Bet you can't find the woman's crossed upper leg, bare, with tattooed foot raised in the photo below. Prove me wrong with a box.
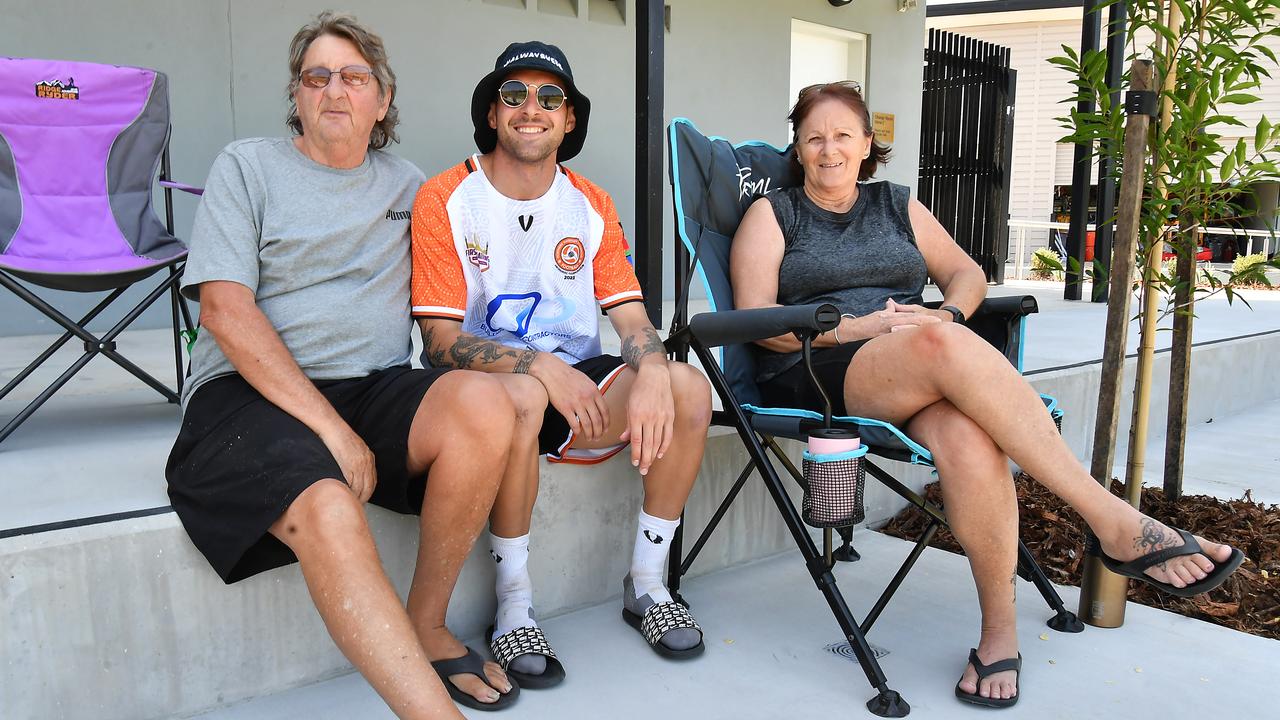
[845,323,1231,587]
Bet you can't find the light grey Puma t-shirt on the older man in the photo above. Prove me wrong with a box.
[182,138,425,406]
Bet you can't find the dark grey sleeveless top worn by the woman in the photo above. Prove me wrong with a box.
[756,182,928,382]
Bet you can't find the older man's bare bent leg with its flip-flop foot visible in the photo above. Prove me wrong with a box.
[408,372,515,702]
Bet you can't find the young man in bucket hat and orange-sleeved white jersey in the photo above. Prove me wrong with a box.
[412,42,710,702]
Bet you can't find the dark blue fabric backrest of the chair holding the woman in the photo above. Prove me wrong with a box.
[668,118,803,405]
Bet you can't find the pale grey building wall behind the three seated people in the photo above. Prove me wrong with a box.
[0,0,924,336]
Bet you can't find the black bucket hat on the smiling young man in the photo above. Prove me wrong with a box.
[471,41,591,163]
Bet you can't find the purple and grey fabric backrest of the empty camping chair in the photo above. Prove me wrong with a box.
[0,58,186,290]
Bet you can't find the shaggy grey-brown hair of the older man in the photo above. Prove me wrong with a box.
[285,10,399,150]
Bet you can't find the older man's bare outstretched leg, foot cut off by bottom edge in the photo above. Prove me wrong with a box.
[270,479,462,720]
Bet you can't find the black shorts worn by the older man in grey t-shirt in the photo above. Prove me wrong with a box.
[165,368,445,584]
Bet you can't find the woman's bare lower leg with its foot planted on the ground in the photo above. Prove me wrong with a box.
[906,400,1018,698]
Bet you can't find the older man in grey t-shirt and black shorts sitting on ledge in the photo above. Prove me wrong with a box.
[166,13,517,719]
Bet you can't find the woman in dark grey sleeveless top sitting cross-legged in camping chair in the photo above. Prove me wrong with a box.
[731,82,1239,707]
